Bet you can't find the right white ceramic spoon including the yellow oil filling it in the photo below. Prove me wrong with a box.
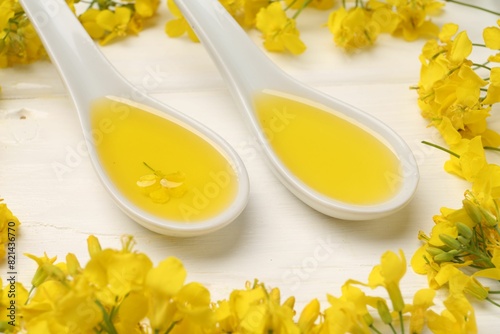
[175,0,419,220]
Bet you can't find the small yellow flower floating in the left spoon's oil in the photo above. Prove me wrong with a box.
[137,163,187,203]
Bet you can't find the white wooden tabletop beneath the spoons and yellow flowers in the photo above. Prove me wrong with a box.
[0,0,500,333]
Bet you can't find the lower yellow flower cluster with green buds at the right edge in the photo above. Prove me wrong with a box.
[412,136,500,306]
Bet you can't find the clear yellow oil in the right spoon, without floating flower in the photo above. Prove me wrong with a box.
[254,91,402,205]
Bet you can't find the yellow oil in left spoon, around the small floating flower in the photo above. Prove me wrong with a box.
[91,97,238,222]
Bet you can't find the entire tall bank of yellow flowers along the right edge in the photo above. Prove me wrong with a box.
[412,11,500,322]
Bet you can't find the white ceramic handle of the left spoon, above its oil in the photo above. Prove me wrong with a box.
[19,0,128,114]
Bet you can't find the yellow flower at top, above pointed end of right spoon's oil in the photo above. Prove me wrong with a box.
[255,2,306,55]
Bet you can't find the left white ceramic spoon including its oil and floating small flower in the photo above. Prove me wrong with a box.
[20,0,249,236]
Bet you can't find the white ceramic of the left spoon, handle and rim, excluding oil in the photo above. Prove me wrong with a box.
[20,0,249,236]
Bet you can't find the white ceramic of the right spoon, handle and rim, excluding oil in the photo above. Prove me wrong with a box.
[175,0,419,220]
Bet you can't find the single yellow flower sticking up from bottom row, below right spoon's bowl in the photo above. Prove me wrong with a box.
[368,250,406,312]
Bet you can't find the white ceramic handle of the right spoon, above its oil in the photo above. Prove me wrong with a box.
[174,0,286,100]
